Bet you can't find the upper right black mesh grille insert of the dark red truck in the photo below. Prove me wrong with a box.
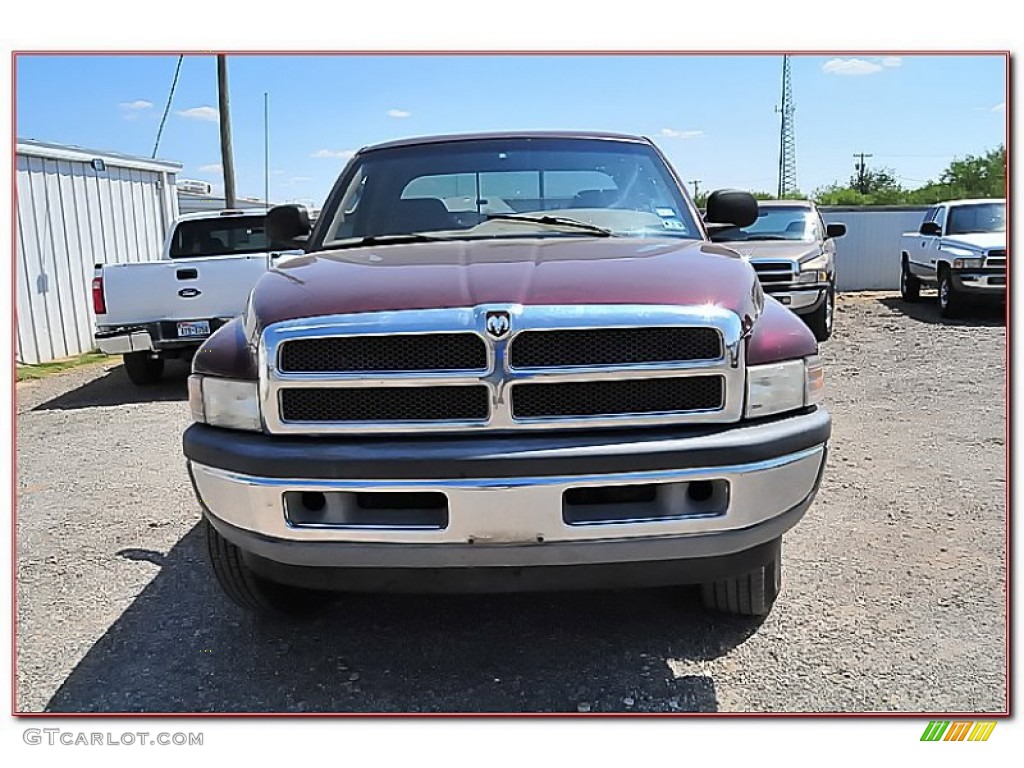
[509,328,722,369]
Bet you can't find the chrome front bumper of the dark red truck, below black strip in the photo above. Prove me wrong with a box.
[189,444,826,567]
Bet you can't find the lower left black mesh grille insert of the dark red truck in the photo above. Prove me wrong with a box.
[281,386,489,422]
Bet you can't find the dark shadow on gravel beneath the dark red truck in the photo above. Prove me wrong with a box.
[46,525,761,713]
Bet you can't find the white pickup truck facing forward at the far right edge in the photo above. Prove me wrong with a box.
[900,199,1007,317]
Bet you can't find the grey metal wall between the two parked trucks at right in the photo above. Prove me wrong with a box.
[821,206,928,291]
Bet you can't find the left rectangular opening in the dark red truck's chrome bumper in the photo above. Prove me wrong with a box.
[284,490,449,530]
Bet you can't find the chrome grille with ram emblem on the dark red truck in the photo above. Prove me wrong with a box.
[259,304,744,434]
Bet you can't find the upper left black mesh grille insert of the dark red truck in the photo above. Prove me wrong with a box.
[280,333,487,373]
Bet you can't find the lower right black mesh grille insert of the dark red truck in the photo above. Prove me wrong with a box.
[512,376,725,419]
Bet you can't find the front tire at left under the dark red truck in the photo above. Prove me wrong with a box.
[203,518,331,618]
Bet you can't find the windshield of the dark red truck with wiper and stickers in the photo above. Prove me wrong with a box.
[322,137,703,248]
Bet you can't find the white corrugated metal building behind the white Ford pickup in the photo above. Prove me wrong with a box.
[15,139,181,364]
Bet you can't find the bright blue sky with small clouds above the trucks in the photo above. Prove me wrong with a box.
[16,54,1006,205]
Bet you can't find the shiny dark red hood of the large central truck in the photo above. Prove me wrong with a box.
[252,238,760,328]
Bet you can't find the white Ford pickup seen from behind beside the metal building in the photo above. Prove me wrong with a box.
[92,209,281,385]
